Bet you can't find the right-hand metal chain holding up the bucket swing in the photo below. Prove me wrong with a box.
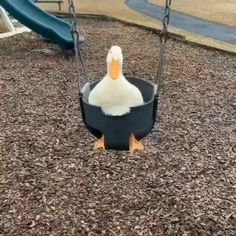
[156,0,171,96]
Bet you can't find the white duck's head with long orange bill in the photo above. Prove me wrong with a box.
[107,46,123,80]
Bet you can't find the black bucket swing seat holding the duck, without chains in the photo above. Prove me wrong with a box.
[80,77,158,150]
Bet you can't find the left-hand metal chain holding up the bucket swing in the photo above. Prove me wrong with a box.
[68,0,88,94]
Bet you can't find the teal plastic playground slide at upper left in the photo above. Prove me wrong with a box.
[0,0,84,49]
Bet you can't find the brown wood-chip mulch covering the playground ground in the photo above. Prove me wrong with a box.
[0,19,236,236]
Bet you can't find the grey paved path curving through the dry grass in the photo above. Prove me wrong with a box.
[126,0,236,45]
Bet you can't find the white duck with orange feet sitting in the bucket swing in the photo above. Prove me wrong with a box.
[88,45,144,152]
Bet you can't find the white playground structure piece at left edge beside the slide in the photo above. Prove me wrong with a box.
[0,6,31,38]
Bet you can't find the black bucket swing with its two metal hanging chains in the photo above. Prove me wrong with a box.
[69,0,171,150]
